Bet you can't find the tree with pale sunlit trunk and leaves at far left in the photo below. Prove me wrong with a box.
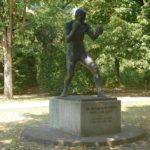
[0,0,46,99]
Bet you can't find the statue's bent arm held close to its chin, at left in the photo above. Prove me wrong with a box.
[64,21,80,42]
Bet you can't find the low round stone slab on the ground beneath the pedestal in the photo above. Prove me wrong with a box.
[21,124,145,146]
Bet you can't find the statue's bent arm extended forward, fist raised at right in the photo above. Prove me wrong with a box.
[87,25,103,41]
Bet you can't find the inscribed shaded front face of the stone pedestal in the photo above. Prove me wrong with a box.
[81,101,121,136]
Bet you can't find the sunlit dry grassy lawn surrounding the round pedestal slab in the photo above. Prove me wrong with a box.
[0,97,150,150]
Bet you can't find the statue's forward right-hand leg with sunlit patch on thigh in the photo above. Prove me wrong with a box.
[82,55,106,97]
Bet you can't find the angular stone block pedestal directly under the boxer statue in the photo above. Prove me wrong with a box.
[49,96,121,136]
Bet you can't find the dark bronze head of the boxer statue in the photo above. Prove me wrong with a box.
[75,8,86,22]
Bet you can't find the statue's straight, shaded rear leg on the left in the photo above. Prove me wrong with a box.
[60,60,75,97]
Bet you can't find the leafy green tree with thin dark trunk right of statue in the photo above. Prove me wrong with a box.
[75,0,143,87]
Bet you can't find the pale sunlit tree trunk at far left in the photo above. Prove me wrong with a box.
[3,0,14,99]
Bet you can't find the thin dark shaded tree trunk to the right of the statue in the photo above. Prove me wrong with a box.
[115,57,120,87]
